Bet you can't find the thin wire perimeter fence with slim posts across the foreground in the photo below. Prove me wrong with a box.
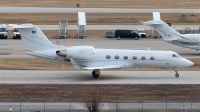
[0,91,200,112]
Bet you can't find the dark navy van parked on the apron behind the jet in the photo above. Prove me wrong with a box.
[115,29,140,40]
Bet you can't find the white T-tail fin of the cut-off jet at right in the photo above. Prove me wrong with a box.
[143,12,182,41]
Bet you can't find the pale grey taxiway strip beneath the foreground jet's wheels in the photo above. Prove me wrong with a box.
[0,70,200,84]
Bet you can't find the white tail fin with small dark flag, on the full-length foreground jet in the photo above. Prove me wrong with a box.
[8,24,55,51]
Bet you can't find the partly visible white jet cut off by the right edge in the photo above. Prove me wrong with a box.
[143,12,200,50]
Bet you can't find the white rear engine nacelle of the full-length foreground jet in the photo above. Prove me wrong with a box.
[56,46,95,59]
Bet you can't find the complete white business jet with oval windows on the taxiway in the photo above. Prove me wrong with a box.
[9,24,194,78]
